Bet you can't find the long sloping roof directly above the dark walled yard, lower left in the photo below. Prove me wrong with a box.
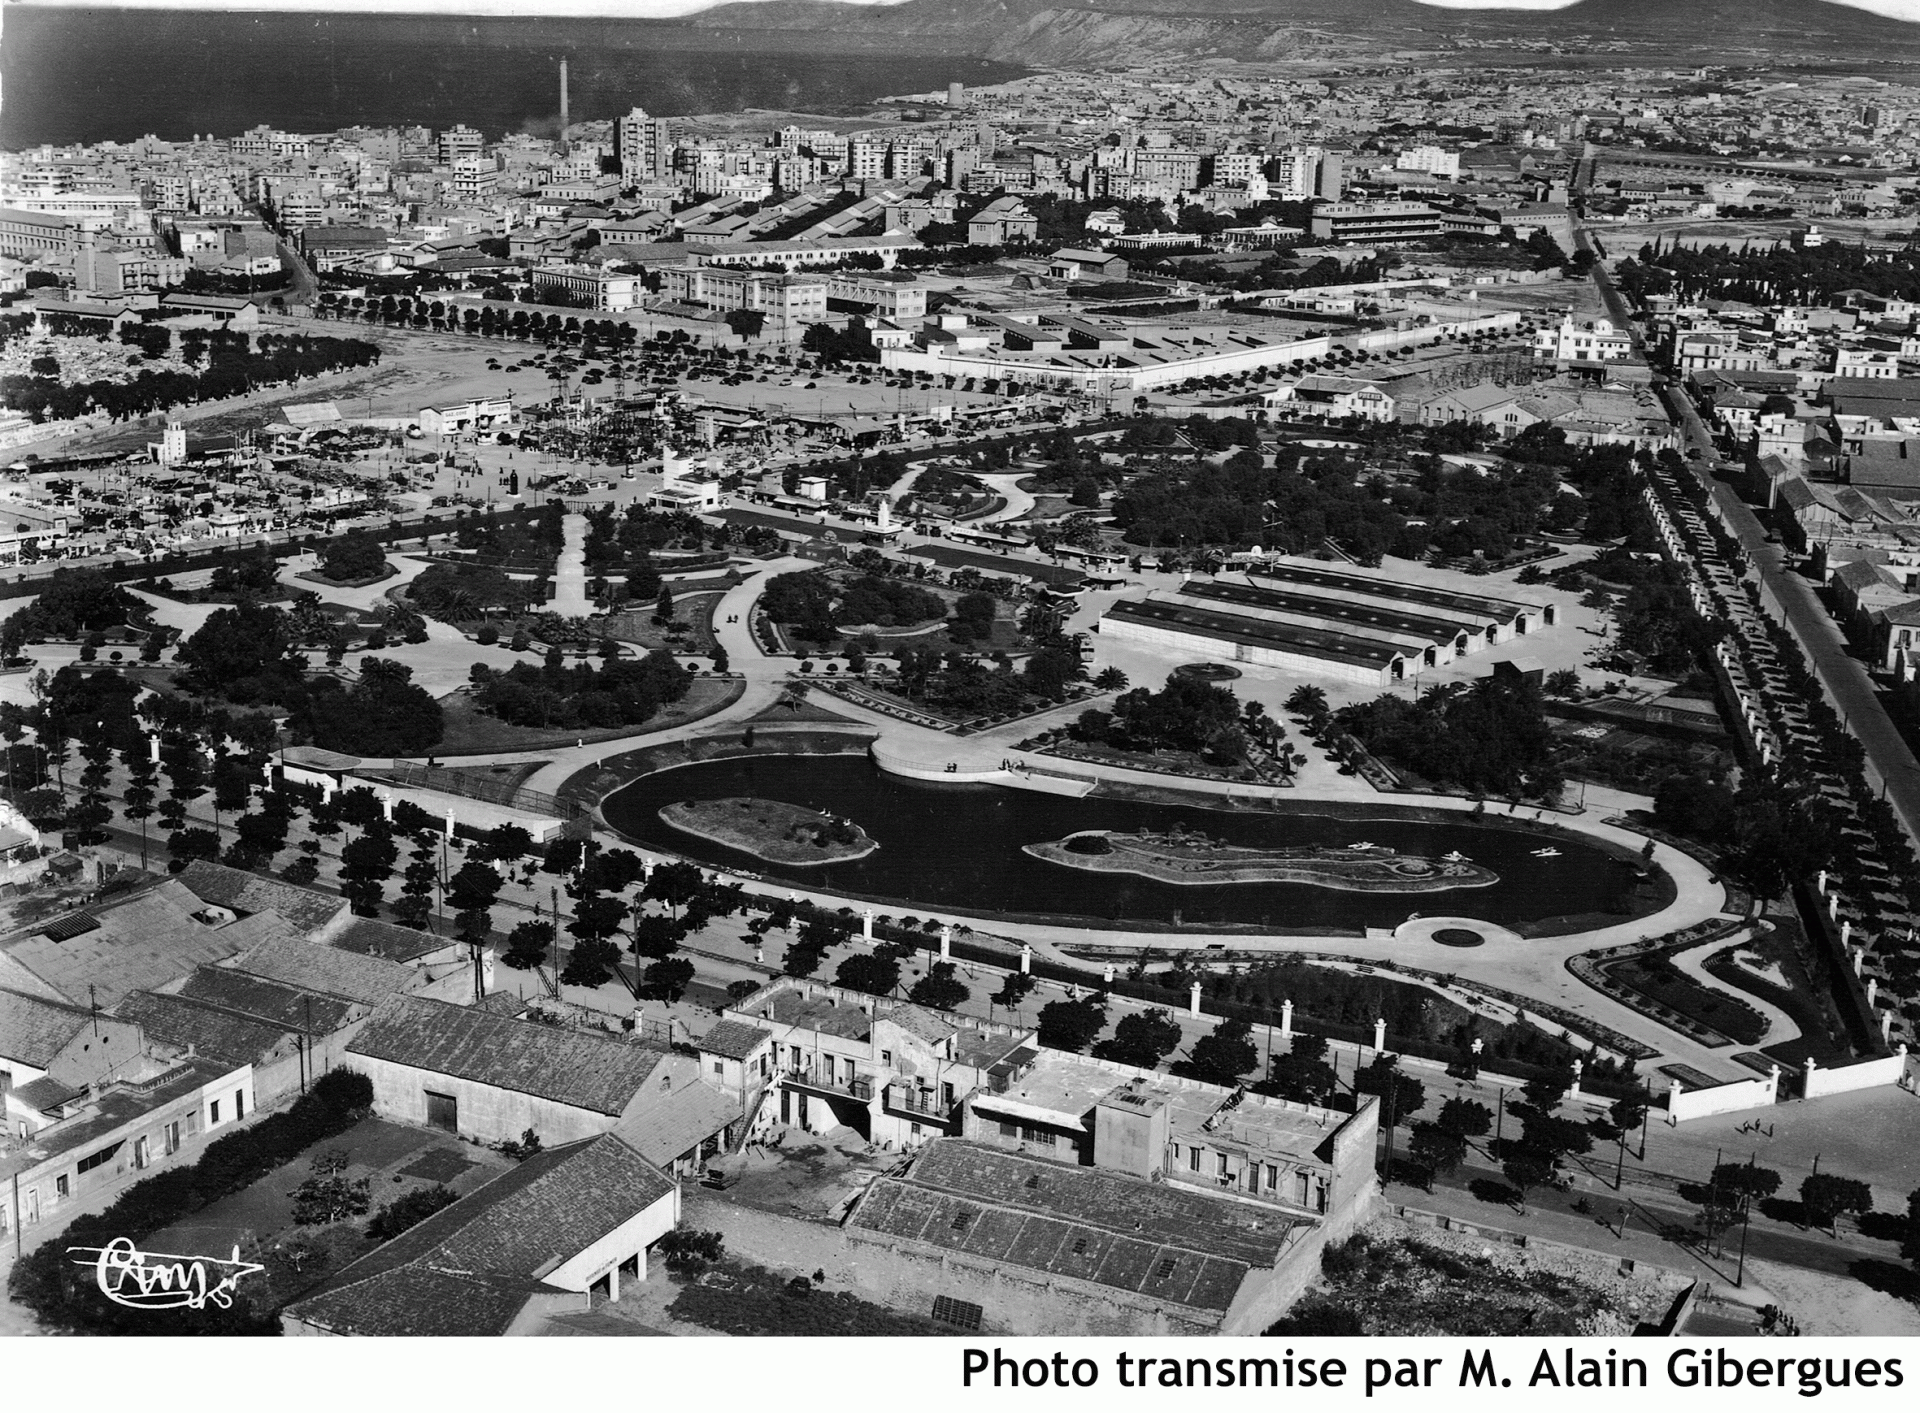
[348,996,666,1115]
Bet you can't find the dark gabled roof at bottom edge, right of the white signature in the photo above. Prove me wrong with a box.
[288,1135,674,1334]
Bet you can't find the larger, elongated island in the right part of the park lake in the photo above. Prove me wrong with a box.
[1023,829,1500,893]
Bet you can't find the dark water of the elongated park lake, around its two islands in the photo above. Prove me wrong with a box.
[601,754,1670,933]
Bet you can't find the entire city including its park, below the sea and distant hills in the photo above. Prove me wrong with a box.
[0,56,1920,1338]
